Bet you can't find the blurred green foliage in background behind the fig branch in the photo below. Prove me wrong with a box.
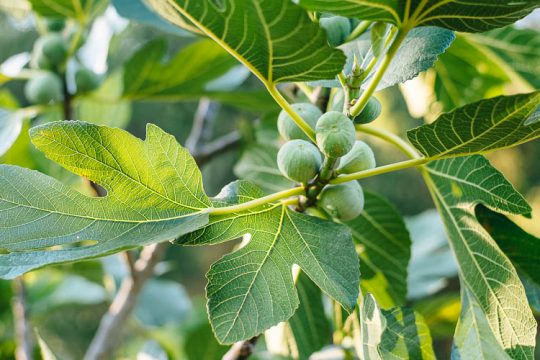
[0,0,540,360]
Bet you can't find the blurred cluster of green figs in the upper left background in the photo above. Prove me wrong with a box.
[24,19,101,104]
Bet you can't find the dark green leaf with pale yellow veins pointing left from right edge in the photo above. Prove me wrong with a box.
[407,91,540,159]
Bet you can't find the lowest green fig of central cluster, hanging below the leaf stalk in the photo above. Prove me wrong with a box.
[317,181,364,221]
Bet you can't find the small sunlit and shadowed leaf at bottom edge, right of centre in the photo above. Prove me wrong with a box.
[355,294,435,360]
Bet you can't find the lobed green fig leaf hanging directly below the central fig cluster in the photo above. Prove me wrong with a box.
[178,182,360,343]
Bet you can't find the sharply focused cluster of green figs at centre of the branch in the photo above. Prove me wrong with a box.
[277,98,381,221]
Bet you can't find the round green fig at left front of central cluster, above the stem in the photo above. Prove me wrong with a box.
[277,139,322,184]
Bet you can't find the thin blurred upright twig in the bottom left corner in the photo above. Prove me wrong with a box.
[12,277,33,360]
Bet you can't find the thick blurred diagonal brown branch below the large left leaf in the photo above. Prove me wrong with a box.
[84,243,169,360]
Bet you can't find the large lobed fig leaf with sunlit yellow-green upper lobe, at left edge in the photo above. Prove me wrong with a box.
[0,122,212,278]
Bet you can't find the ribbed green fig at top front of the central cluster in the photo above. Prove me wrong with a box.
[315,111,356,158]
